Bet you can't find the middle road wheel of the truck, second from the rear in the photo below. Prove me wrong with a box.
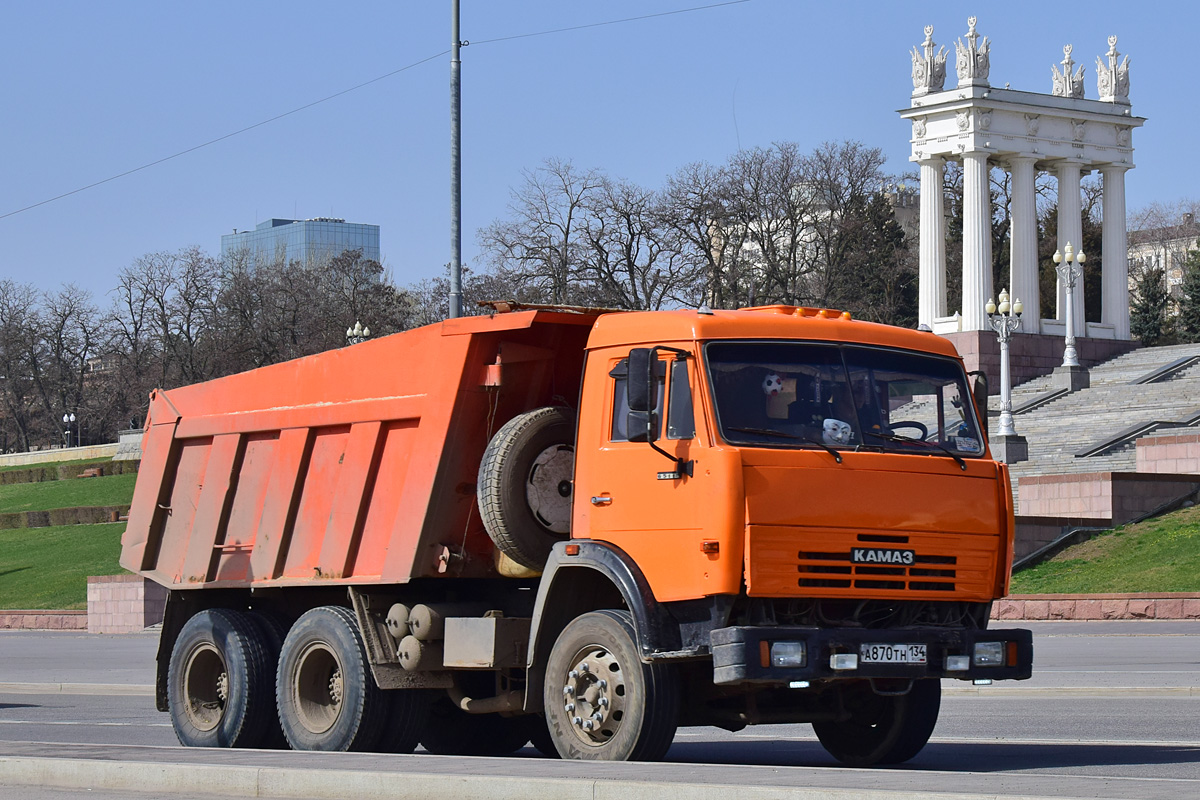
[275,606,386,751]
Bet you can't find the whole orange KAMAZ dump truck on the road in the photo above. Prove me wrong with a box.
[121,305,1033,765]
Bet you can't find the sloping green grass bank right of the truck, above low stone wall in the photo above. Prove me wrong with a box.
[1010,506,1200,595]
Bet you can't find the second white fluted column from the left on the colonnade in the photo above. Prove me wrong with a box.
[962,152,992,331]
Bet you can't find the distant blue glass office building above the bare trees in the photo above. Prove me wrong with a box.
[221,217,379,264]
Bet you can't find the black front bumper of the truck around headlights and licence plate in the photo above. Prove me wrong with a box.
[712,626,1033,685]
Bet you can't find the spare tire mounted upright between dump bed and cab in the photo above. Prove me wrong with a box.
[476,408,575,570]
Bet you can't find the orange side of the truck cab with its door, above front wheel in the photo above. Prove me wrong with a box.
[572,347,744,601]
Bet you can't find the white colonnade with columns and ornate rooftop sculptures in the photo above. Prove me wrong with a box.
[900,17,1145,339]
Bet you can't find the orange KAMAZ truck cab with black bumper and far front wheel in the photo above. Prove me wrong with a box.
[535,306,1032,764]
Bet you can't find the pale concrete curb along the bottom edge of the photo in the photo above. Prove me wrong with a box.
[0,758,1099,800]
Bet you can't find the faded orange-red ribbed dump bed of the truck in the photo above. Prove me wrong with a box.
[121,311,596,589]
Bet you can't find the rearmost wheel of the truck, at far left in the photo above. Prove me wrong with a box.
[167,608,274,747]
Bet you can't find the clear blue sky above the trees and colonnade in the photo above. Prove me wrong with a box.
[0,0,1185,303]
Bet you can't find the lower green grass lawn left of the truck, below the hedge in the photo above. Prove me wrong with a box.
[0,522,125,608]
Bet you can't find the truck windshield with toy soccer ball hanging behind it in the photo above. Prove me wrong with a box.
[704,342,983,457]
